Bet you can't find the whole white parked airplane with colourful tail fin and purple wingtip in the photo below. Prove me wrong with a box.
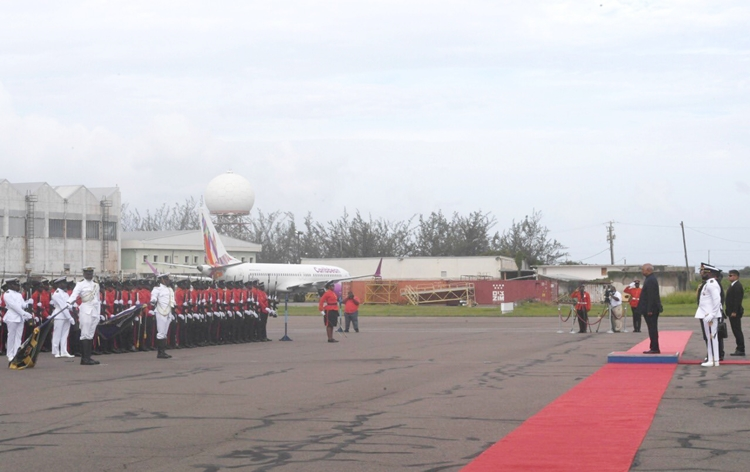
[162,208,383,293]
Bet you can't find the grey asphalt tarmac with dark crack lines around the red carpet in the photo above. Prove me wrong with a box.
[0,317,750,472]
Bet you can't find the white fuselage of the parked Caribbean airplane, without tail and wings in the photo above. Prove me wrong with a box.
[200,262,349,292]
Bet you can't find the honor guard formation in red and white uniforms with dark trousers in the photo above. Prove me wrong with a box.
[0,267,278,365]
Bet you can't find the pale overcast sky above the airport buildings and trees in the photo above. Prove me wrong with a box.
[0,0,750,269]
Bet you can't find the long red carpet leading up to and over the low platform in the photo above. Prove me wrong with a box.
[462,331,692,472]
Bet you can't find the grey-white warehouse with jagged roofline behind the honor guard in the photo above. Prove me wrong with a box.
[0,179,121,278]
